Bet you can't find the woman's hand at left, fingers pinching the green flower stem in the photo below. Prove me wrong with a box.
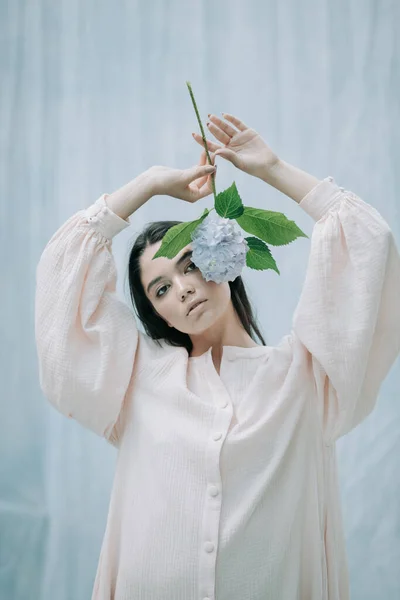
[148,150,216,202]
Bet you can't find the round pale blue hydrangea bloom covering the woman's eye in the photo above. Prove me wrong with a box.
[191,212,249,283]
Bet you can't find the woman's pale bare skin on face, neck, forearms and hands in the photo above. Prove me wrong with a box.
[106,113,319,372]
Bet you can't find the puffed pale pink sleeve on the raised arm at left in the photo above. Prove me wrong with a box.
[35,194,140,446]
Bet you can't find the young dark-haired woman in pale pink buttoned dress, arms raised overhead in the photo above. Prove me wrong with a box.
[35,115,400,600]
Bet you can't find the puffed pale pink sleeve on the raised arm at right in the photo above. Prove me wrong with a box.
[291,177,400,444]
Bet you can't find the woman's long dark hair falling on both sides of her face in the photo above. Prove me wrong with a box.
[127,221,266,354]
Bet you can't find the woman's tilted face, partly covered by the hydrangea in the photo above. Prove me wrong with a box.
[140,241,231,334]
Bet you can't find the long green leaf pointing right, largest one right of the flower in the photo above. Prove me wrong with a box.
[236,206,308,246]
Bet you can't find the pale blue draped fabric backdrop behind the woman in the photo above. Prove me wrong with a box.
[0,0,400,600]
